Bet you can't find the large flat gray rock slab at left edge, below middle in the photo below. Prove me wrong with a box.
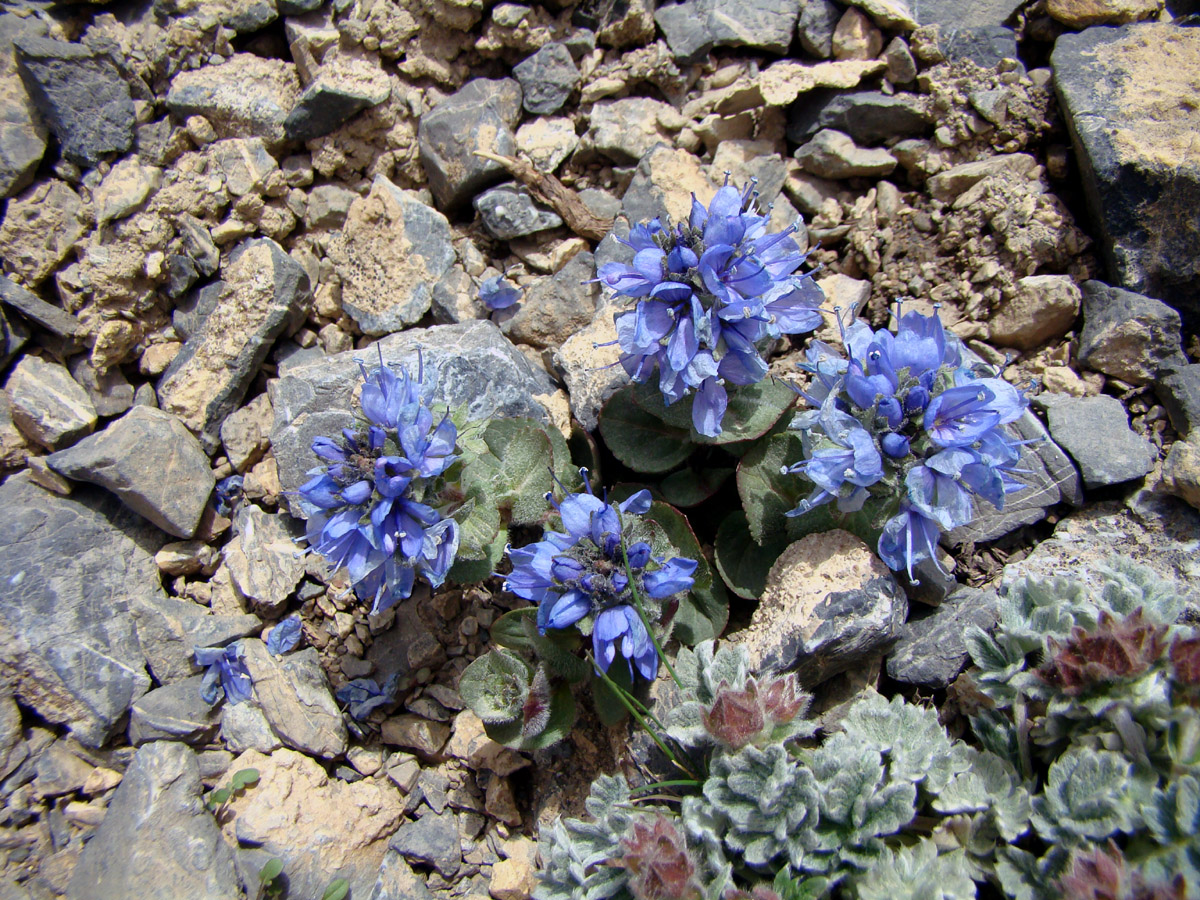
[0,474,162,746]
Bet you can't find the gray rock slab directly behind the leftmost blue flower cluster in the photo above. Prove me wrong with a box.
[271,319,554,515]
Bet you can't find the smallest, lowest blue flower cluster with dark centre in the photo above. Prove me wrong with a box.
[504,469,697,680]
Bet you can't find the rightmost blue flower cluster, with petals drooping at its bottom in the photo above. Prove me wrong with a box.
[784,312,1028,577]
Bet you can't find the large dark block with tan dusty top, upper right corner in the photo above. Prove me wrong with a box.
[1050,23,1200,328]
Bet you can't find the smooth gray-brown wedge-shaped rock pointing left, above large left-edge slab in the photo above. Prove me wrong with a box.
[47,407,215,538]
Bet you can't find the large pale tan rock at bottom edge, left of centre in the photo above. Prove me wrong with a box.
[224,750,403,898]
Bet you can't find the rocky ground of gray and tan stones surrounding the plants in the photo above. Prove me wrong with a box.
[0,0,1200,900]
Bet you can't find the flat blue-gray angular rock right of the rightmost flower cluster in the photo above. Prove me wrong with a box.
[1038,394,1157,487]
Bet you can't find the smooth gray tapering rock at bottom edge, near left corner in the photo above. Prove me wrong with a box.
[67,742,241,900]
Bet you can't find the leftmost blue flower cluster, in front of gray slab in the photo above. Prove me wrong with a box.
[299,360,460,614]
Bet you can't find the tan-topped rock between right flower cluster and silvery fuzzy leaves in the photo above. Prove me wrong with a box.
[733,530,908,686]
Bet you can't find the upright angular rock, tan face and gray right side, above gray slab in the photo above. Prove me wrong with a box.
[326,175,455,335]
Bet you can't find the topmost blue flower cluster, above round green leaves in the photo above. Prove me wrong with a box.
[598,184,824,437]
